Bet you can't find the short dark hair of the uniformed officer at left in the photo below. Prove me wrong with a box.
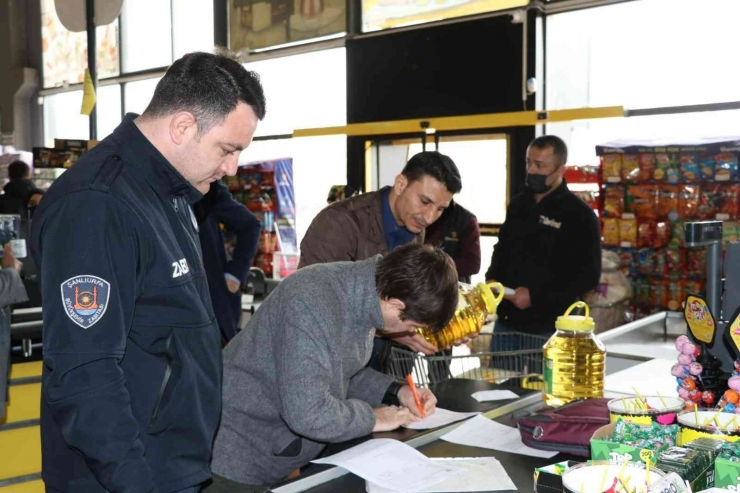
[142,49,266,135]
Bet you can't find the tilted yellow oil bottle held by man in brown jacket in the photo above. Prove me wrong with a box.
[418,282,504,349]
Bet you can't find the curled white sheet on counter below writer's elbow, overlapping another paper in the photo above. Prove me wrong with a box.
[311,438,461,491]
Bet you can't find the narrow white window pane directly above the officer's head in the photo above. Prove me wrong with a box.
[172,0,213,60]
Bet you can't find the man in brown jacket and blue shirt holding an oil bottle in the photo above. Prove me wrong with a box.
[298,152,462,370]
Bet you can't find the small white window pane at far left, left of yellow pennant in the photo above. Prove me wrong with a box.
[44,91,90,147]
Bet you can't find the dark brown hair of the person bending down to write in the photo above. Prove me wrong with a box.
[375,243,459,331]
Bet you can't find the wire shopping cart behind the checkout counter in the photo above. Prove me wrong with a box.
[389,332,548,390]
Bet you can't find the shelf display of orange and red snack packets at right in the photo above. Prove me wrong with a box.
[596,136,740,318]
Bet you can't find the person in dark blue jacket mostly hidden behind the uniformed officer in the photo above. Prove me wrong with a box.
[194,180,262,343]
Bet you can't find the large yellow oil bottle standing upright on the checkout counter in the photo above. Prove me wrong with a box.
[542,301,606,407]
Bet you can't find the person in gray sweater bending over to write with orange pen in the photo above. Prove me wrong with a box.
[208,244,458,493]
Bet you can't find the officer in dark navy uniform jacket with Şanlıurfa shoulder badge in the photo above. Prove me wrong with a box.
[31,53,265,493]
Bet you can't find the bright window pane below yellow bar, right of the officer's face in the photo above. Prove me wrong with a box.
[239,135,347,245]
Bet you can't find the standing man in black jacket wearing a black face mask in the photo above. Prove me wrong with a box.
[486,135,601,350]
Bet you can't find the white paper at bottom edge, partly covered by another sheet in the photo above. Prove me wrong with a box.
[365,457,516,493]
